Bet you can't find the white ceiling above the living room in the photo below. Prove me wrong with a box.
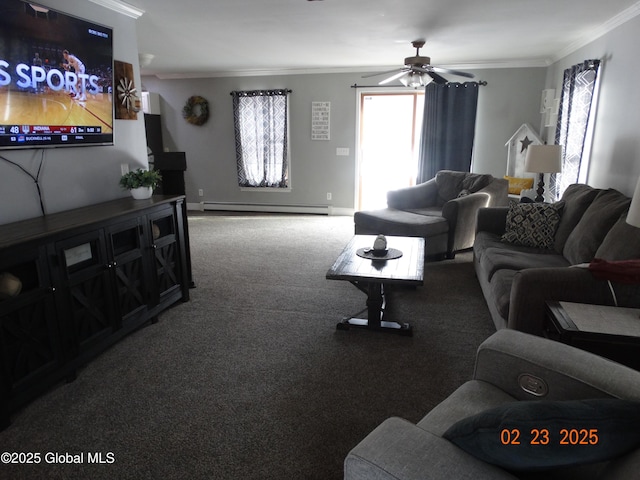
[99,0,640,78]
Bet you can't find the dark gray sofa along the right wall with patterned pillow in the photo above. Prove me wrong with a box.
[473,184,640,335]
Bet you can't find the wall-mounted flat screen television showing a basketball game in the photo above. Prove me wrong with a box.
[0,0,114,149]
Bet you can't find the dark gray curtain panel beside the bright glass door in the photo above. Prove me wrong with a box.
[417,82,479,183]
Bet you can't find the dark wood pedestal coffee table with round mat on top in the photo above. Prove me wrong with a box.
[327,235,424,336]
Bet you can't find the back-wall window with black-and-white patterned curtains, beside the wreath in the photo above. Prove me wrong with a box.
[231,90,291,188]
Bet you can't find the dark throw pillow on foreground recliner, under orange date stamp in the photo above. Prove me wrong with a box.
[443,398,640,471]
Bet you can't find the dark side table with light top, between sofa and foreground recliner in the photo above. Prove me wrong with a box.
[544,301,640,370]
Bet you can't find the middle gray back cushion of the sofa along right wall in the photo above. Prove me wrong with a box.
[562,189,631,265]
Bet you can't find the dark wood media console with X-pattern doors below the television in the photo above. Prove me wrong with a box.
[0,196,191,429]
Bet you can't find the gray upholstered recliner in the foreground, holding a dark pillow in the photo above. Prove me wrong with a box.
[344,329,640,480]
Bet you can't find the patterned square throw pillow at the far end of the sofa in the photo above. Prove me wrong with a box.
[502,201,564,248]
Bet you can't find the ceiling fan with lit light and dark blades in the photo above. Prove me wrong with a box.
[362,40,473,88]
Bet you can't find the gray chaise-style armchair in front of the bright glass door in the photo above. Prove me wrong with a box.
[354,170,509,258]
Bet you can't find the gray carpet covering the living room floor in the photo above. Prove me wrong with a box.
[0,214,494,480]
